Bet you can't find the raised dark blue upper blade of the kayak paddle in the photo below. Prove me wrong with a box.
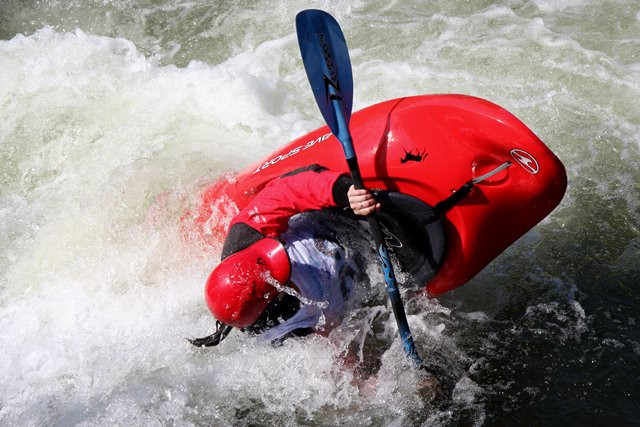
[296,9,353,135]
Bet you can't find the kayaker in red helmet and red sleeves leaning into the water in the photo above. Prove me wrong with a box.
[190,165,380,346]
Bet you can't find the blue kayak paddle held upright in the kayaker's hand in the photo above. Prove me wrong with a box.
[296,9,422,365]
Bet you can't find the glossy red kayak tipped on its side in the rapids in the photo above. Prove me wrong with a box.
[192,95,567,295]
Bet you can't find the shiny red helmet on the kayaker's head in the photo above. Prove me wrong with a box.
[205,238,291,328]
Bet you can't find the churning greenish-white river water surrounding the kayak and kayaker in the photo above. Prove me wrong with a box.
[0,0,640,425]
